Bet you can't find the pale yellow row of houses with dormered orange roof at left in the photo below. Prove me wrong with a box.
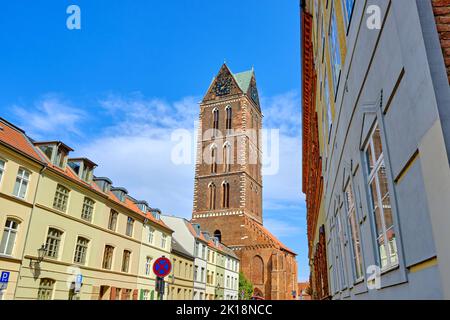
[0,119,173,300]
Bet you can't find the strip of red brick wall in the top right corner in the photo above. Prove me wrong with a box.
[432,0,450,83]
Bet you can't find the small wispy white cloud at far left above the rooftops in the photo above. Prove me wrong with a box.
[12,95,87,140]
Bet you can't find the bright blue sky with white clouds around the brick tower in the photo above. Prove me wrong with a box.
[0,0,309,280]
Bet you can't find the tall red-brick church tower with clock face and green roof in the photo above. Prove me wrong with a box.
[192,64,297,299]
